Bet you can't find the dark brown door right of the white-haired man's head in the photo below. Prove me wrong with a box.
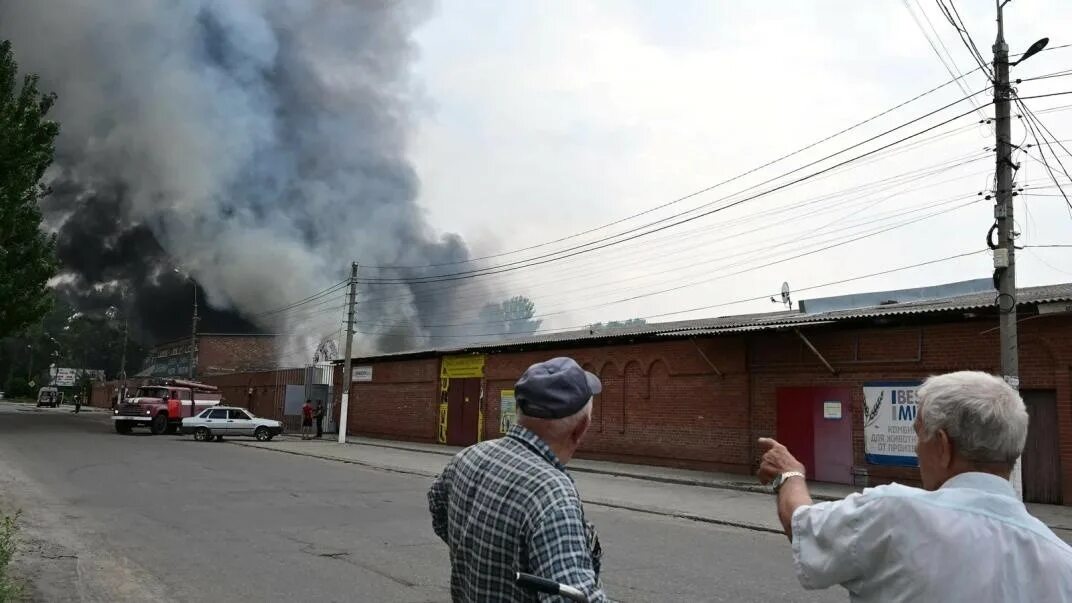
[1022,389,1062,504]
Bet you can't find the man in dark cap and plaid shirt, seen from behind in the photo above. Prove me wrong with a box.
[428,358,606,602]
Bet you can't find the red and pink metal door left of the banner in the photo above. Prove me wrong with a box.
[777,387,852,484]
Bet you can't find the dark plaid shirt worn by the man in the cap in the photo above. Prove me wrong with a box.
[428,425,606,602]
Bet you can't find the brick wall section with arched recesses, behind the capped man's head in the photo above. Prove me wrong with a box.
[483,338,750,472]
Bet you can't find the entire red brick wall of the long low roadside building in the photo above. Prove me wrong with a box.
[323,309,1072,502]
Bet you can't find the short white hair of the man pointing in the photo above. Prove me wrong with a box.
[918,370,1027,465]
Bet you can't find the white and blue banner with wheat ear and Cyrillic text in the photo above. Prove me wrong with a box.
[864,381,921,467]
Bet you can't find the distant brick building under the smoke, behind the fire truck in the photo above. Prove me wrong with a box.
[138,333,282,377]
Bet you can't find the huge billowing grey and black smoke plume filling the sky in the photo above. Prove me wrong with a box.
[0,0,478,356]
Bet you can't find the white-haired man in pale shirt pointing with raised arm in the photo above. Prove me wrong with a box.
[759,371,1072,603]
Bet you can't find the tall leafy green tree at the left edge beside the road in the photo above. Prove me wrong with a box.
[0,41,59,337]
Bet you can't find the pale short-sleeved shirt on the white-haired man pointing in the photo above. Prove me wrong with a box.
[792,473,1072,603]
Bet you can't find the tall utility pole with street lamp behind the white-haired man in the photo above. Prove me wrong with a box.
[993,0,1024,499]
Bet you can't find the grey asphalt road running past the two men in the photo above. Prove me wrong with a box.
[0,403,847,602]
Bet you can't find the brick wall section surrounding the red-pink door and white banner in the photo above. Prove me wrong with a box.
[748,317,1072,501]
